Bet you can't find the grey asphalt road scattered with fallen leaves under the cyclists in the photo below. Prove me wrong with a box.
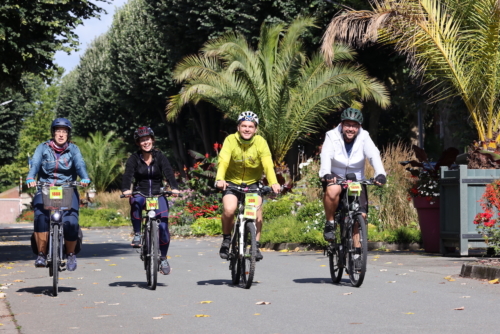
[0,224,500,334]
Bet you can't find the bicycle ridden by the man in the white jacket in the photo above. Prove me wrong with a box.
[325,177,375,287]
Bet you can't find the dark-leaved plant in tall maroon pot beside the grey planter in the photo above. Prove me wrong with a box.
[400,145,459,253]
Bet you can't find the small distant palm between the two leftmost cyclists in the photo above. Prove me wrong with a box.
[73,131,127,192]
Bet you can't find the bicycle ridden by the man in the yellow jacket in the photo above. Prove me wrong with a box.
[226,183,271,289]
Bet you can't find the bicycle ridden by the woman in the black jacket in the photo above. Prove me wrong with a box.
[120,190,177,290]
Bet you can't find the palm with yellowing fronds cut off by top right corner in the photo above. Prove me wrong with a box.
[322,0,500,154]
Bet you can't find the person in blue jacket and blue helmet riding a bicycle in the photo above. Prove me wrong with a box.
[26,118,90,271]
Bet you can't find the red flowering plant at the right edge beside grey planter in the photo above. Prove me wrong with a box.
[474,180,500,255]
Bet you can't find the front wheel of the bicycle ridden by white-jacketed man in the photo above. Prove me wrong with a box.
[348,214,368,287]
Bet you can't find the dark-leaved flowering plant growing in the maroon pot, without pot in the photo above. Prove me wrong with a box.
[400,145,458,204]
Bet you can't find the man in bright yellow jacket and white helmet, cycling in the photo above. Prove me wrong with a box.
[215,111,280,261]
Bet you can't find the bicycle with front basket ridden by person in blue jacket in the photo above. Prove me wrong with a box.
[36,181,80,297]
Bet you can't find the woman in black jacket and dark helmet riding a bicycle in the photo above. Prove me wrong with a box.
[121,126,179,275]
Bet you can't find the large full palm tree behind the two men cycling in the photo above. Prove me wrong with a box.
[167,17,389,163]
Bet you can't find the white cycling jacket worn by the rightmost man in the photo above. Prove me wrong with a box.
[319,124,386,180]
